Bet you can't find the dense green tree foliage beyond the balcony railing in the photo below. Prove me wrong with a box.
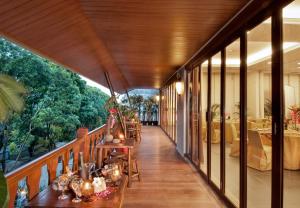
[0,38,109,172]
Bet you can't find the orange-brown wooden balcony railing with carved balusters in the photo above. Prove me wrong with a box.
[5,125,106,207]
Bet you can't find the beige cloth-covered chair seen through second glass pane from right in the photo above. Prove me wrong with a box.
[247,130,272,171]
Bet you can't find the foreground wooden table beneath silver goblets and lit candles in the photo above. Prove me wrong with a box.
[25,175,128,208]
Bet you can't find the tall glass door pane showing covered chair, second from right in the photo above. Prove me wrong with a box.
[247,18,272,208]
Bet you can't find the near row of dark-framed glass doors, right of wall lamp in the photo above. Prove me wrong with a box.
[187,0,300,208]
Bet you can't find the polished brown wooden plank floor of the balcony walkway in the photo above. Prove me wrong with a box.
[123,126,225,208]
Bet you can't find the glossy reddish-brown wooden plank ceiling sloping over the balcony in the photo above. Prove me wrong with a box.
[0,0,247,92]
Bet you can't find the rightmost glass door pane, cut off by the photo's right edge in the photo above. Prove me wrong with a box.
[282,0,300,208]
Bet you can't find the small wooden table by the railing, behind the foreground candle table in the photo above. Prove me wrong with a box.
[96,139,135,187]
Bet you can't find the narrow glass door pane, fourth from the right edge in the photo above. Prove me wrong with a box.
[211,52,221,187]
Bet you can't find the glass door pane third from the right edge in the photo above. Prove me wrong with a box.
[225,39,240,207]
